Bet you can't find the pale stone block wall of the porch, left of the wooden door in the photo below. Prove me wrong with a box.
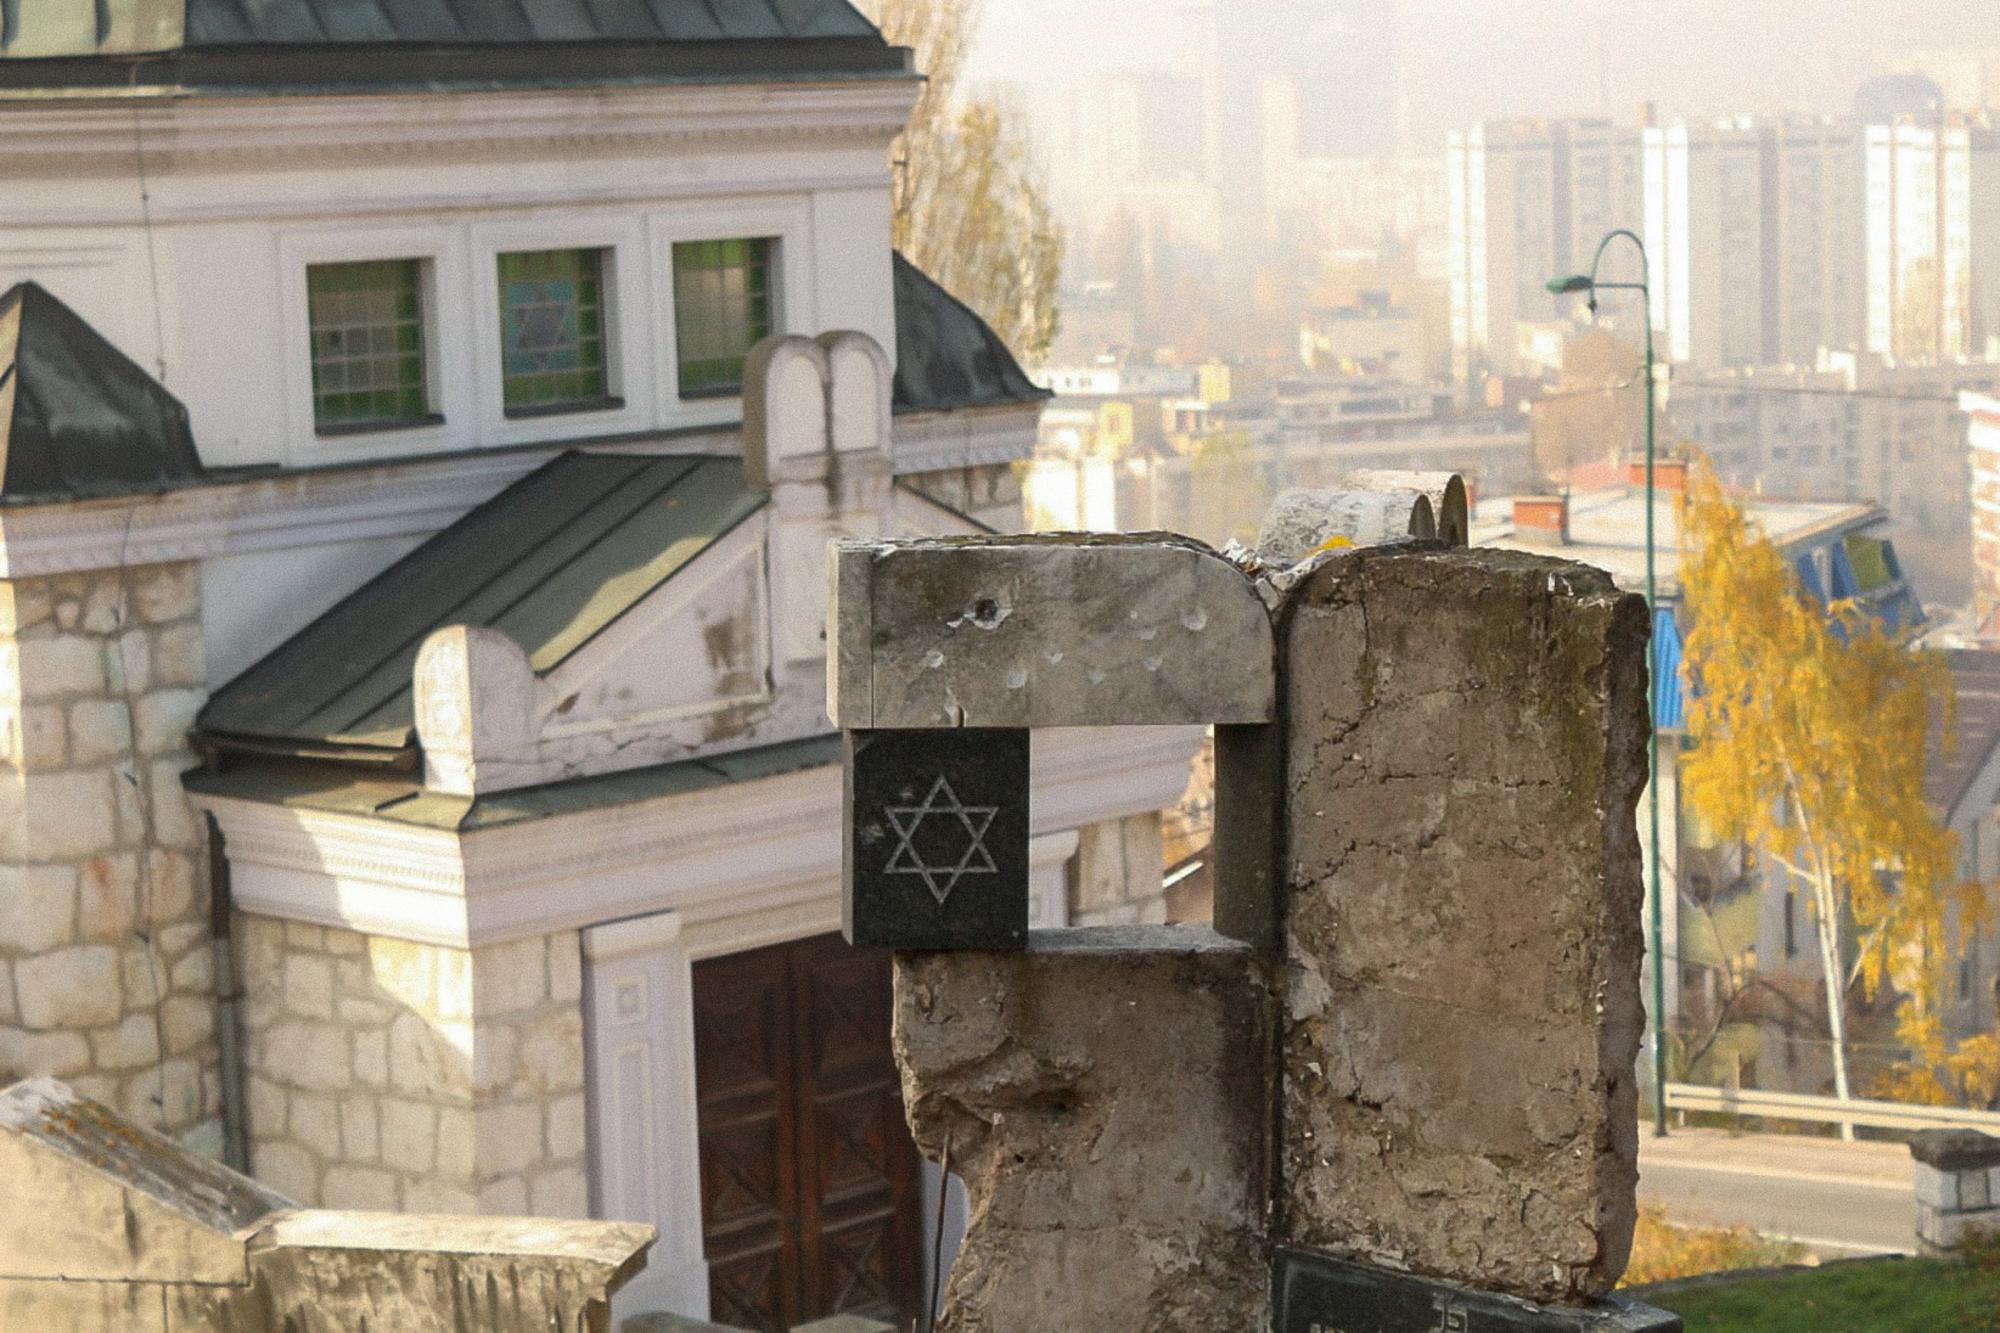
[236,913,590,1217]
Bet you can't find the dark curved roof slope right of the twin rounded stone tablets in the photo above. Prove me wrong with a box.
[894,254,1052,412]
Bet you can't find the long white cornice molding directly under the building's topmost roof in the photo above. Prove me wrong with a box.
[0,80,920,172]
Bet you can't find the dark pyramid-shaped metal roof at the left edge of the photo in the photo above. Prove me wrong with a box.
[0,282,204,504]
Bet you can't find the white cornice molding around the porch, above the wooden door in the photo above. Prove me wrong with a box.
[194,727,1200,949]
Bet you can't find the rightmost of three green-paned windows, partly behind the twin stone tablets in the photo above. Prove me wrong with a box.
[674,238,778,398]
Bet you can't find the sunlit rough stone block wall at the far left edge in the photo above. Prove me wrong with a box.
[0,562,222,1153]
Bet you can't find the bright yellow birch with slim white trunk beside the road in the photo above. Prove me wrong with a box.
[1682,462,1976,1120]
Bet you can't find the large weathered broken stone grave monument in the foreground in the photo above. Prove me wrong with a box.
[830,478,1678,1333]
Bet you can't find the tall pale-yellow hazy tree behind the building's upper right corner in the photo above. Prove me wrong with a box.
[862,0,1064,362]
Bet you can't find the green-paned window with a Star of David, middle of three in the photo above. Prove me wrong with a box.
[500,250,612,412]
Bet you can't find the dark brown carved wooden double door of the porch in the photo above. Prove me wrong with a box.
[694,935,924,1333]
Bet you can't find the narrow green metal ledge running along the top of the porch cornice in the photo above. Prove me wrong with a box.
[182,735,840,833]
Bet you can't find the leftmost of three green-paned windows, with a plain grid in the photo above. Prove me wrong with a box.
[306,260,432,432]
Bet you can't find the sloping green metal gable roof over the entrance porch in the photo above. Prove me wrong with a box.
[196,452,768,759]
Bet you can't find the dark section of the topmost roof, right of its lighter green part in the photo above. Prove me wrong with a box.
[186,0,876,46]
